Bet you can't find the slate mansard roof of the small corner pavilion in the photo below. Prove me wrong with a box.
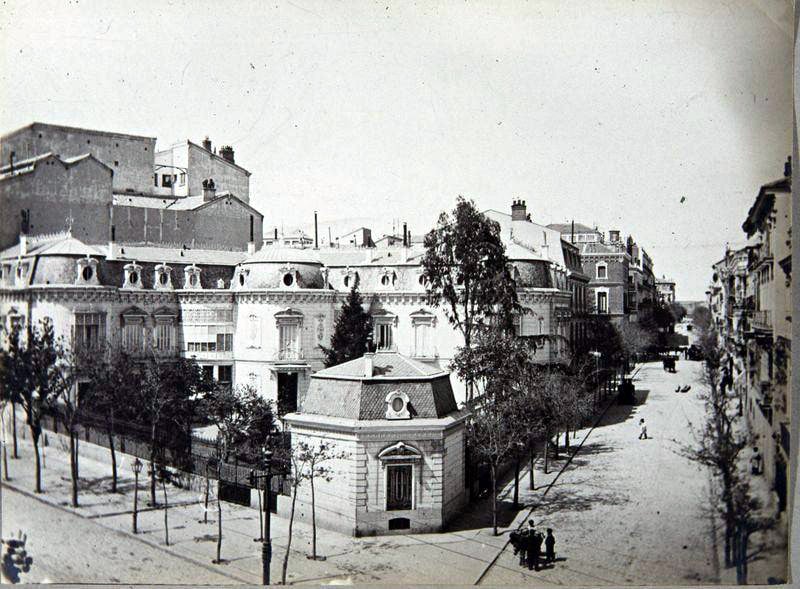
[298,353,458,422]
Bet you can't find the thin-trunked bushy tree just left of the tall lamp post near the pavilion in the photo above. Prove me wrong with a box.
[202,385,275,563]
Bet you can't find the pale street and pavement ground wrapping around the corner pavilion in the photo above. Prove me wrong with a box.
[3,361,718,585]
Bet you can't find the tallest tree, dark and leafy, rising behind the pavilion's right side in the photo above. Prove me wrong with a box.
[422,196,519,401]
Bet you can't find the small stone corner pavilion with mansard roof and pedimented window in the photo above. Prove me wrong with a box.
[279,352,468,536]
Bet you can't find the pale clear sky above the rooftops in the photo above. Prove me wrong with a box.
[0,0,793,300]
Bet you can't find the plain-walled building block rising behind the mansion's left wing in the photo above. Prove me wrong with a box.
[0,123,263,250]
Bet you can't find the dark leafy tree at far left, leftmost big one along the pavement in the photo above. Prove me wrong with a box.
[11,318,61,493]
